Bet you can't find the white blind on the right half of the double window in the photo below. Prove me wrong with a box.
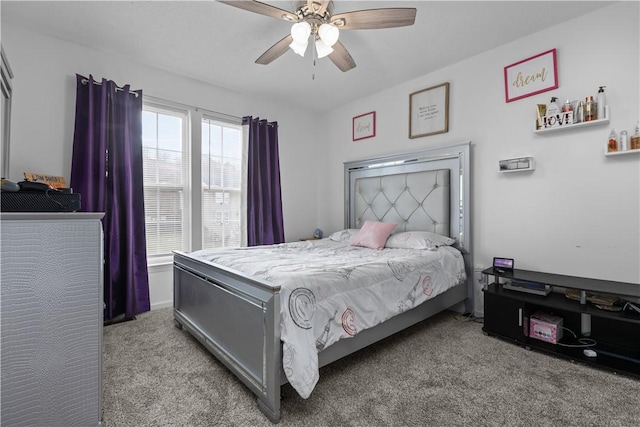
[201,116,243,249]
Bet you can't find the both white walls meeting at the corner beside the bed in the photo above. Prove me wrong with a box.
[2,2,640,307]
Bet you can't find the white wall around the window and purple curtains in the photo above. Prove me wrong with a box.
[2,22,323,308]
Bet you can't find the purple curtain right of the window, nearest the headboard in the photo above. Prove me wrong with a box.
[242,116,284,246]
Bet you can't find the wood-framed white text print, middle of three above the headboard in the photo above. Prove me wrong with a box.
[409,82,449,138]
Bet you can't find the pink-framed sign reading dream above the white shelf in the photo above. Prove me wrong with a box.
[504,49,558,102]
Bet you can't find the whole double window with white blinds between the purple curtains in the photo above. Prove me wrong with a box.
[142,99,244,263]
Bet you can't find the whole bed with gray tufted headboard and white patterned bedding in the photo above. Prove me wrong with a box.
[173,142,473,423]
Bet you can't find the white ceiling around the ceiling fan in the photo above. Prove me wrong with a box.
[1,0,610,111]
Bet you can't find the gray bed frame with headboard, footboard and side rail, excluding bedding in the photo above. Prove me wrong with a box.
[173,142,473,423]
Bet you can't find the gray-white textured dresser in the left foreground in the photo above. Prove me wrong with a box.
[0,213,103,427]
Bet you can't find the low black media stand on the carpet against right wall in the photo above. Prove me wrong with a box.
[482,268,640,378]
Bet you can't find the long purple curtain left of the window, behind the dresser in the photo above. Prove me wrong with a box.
[71,75,150,320]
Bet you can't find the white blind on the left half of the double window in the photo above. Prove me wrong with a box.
[142,103,191,258]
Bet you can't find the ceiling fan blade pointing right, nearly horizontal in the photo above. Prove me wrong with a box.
[331,7,416,30]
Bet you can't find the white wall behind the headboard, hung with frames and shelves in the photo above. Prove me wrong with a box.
[318,2,640,294]
